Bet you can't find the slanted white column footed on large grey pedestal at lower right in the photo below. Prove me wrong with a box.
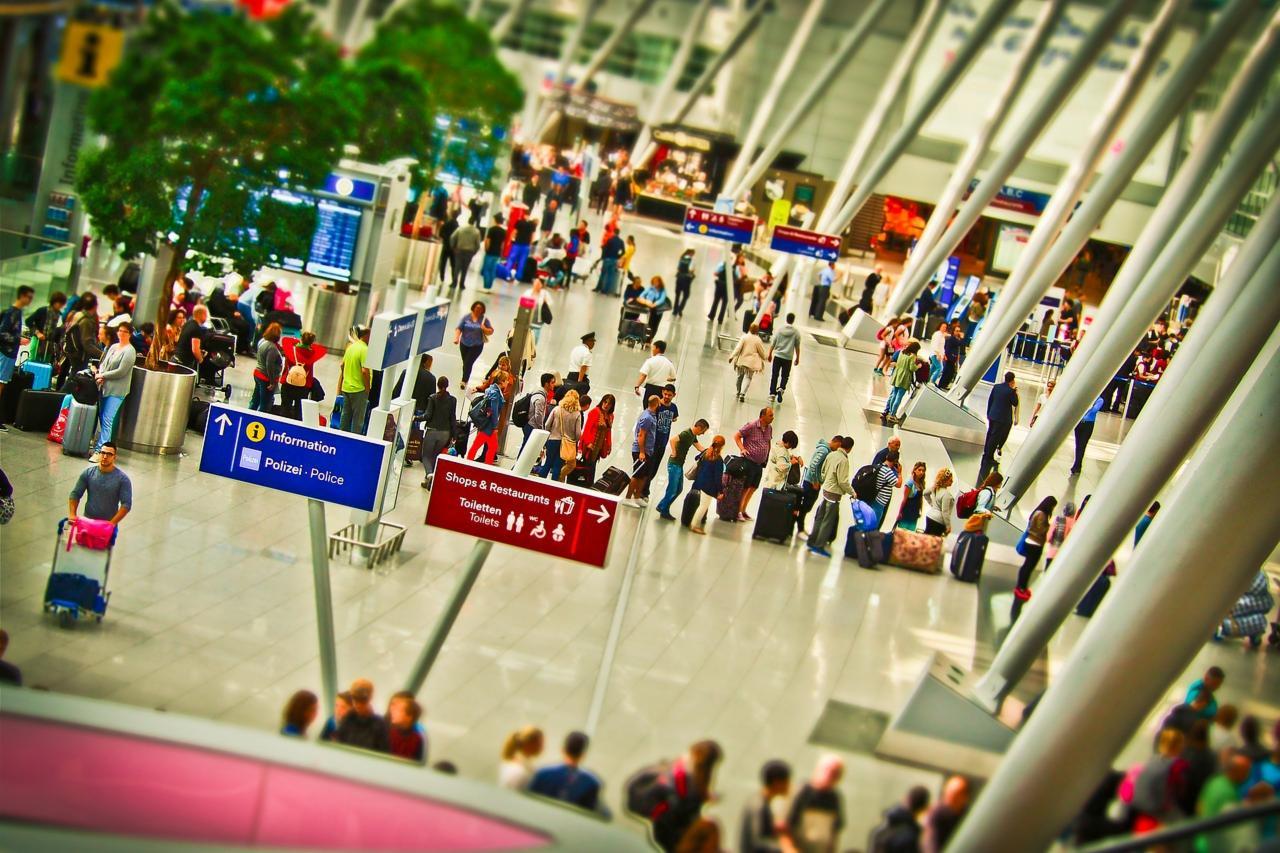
[977,196,1280,708]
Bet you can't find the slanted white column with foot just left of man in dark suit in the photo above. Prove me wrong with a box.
[955,0,1256,400]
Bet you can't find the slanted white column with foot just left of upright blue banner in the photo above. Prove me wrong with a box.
[877,0,1140,319]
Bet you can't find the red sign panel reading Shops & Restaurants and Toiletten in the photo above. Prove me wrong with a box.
[426,456,618,569]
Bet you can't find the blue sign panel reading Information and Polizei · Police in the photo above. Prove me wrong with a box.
[200,403,389,512]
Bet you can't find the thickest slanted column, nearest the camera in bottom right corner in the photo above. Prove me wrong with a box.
[947,337,1280,853]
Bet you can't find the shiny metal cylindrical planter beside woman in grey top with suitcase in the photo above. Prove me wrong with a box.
[115,362,196,456]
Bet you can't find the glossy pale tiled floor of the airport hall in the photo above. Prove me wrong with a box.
[0,213,1277,845]
